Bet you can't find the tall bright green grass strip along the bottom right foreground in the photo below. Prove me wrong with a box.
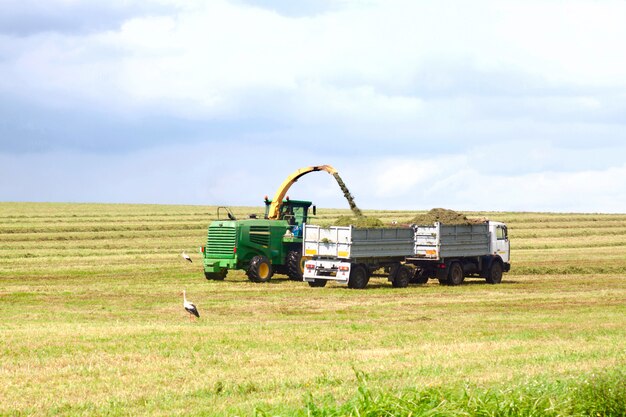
[256,370,626,417]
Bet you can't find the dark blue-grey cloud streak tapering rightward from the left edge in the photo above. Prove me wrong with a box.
[0,96,288,154]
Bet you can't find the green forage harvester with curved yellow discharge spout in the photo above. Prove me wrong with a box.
[200,165,337,282]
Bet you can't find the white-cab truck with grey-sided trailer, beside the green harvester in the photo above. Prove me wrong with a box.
[302,221,511,289]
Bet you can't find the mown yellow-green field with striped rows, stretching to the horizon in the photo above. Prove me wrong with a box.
[0,203,626,416]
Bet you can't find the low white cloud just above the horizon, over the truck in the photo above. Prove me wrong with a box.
[346,143,626,212]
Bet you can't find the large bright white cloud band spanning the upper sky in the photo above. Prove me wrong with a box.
[3,0,626,117]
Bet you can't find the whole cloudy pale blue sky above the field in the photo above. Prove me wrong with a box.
[0,0,626,213]
